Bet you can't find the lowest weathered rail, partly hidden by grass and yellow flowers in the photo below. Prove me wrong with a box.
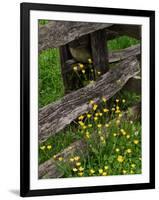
[38,102,141,179]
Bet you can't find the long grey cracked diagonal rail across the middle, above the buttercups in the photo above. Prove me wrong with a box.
[39,57,140,143]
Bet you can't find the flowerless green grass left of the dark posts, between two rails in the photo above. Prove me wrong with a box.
[39,49,64,108]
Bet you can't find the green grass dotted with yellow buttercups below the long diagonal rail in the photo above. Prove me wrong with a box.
[49,99,141,177]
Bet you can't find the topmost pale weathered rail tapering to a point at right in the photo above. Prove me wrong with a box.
[38,21,112,51]
